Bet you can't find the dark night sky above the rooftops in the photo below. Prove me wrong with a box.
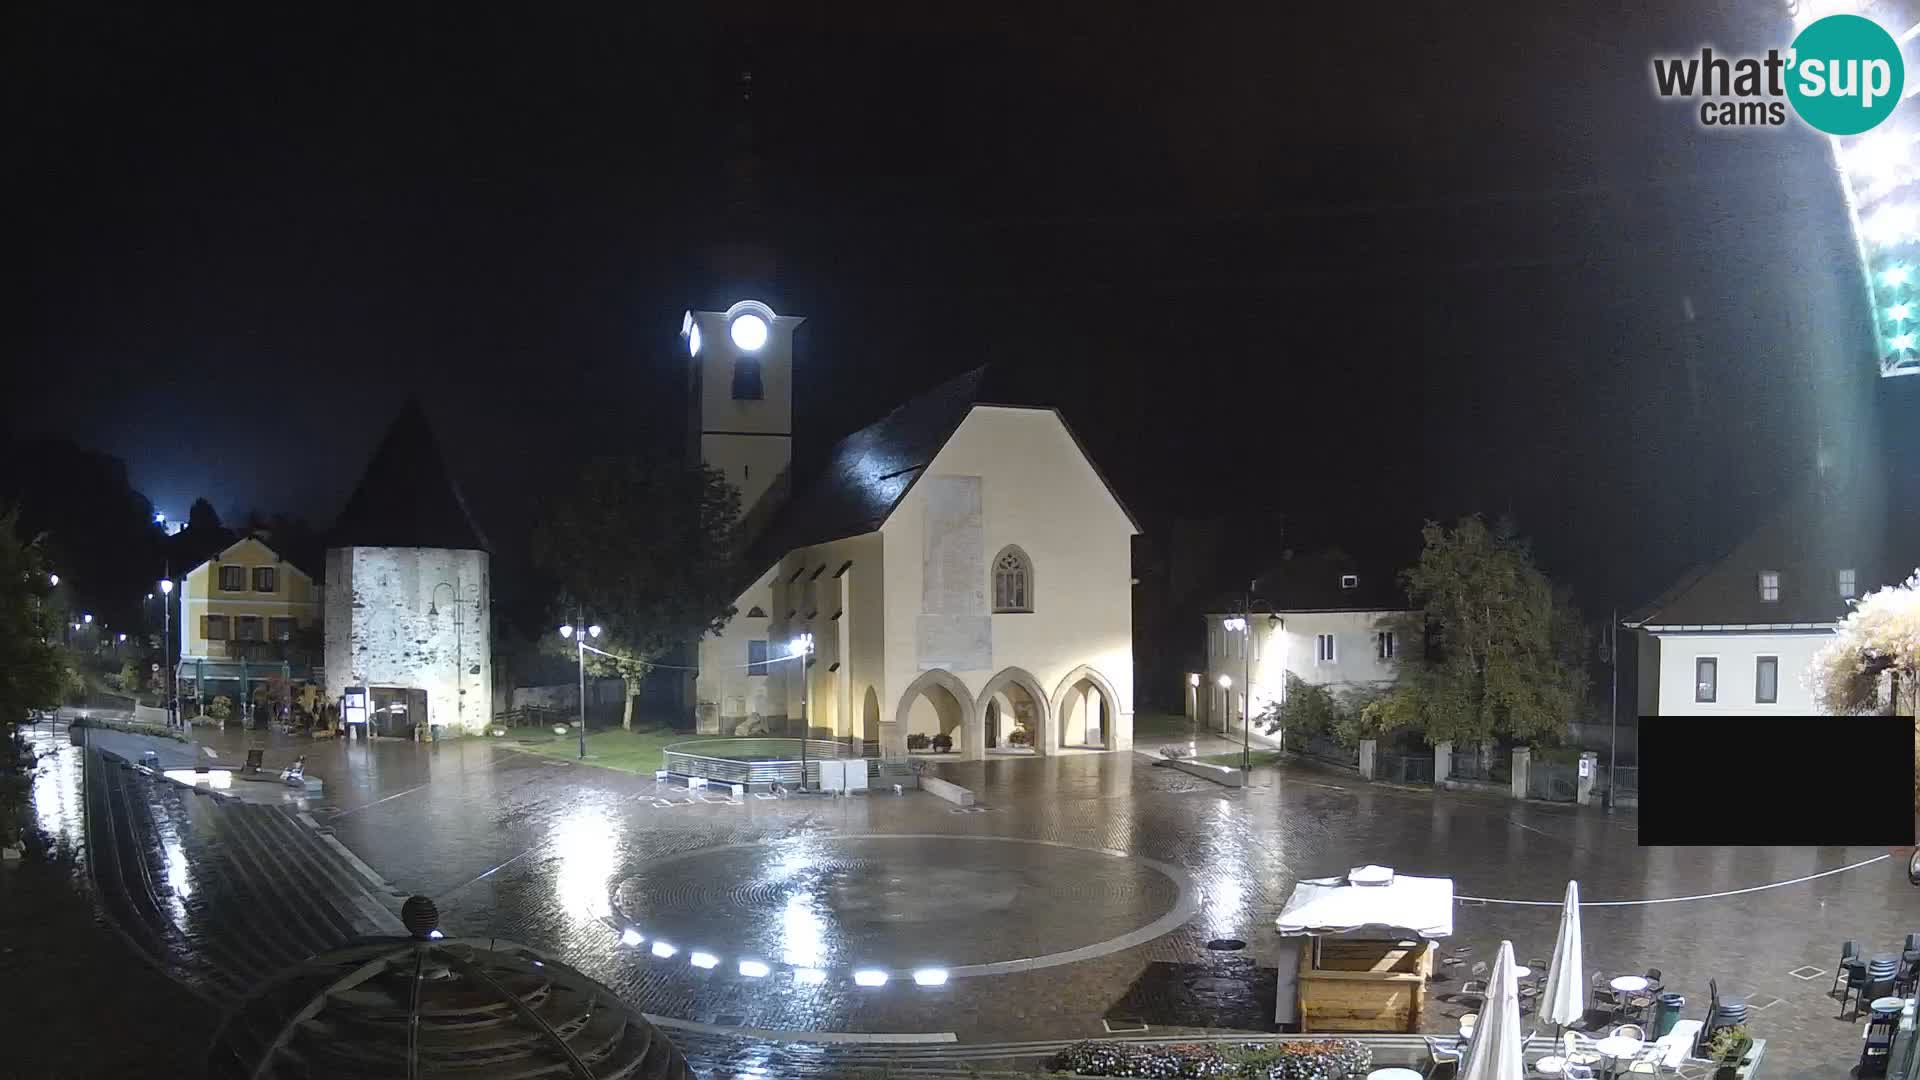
[0,0,1920,609]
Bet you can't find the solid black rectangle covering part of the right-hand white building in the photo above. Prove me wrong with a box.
[1640,715,1914,847]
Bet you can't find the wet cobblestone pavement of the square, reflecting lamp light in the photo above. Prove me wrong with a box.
[30,718,1920,1076]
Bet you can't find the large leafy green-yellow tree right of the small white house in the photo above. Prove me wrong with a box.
[1365,517,1586,744]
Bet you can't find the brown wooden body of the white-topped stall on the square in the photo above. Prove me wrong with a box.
[1294,938,1434,1034]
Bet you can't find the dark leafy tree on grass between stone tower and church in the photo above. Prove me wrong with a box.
[534,457,741,728]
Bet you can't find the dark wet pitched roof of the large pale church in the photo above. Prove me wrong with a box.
[743,365,1139,575]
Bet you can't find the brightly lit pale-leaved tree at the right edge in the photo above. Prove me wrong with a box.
[1807,571,1920,799]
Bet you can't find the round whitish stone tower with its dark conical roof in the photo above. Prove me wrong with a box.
[324,402,493,736]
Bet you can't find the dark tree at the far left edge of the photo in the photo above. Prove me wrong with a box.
[0,509,67,847]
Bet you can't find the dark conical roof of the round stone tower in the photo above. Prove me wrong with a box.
[326,398,488,552]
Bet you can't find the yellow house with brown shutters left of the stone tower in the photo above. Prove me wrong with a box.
[175,536,321,700]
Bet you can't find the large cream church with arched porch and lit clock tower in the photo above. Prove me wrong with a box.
[682,300,1139,759]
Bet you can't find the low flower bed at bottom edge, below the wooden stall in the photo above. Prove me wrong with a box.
[1050,1040,1373,1080]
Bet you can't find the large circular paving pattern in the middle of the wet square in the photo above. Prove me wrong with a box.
[611,834,1198,978]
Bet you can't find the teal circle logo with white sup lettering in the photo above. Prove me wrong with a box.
[1788,15,1907,135]
